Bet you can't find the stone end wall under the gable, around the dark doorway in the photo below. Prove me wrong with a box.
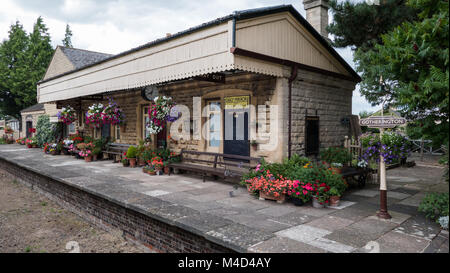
[292,70,355,154]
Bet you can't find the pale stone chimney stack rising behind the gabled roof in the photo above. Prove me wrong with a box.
[303,0,329,39]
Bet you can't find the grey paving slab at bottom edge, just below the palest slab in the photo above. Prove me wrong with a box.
[248,236,326,253]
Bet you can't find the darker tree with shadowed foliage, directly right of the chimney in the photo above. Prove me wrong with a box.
[327,0,416,50]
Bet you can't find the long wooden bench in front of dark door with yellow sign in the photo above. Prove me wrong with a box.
[169,150,262,182]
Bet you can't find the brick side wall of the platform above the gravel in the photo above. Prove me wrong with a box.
[0,159,234,253]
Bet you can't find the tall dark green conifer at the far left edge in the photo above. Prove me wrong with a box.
[0,21,29,119]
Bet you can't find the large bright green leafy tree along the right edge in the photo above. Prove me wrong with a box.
[355,0,449,143]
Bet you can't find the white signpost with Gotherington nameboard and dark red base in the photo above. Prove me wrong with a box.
[359,113,406,219]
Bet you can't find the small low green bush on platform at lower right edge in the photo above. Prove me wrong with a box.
[419,193,448,221]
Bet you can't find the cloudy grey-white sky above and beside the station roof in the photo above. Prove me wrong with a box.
[0,0,373,114]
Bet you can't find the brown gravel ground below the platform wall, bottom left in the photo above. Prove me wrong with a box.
[0,169,144,253]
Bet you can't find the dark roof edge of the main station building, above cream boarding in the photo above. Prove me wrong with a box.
[38,5,361,84]
